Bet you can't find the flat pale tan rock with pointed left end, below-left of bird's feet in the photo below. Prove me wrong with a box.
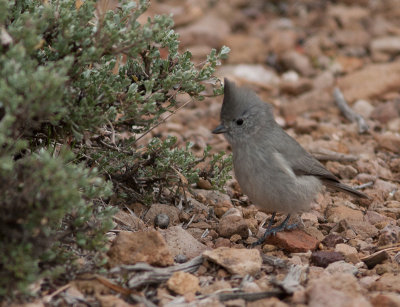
[203,247,262,276]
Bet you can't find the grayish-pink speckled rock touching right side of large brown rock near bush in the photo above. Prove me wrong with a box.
[160,226,207,259]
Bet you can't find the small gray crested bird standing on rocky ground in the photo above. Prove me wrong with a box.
[212,78,369,244]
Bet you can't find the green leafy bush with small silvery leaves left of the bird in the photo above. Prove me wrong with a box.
[0,0,231,296]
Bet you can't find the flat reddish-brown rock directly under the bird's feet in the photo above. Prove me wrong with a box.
[265,230,319,253]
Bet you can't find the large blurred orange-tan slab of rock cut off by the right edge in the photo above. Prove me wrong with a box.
[338,62,400,102]
